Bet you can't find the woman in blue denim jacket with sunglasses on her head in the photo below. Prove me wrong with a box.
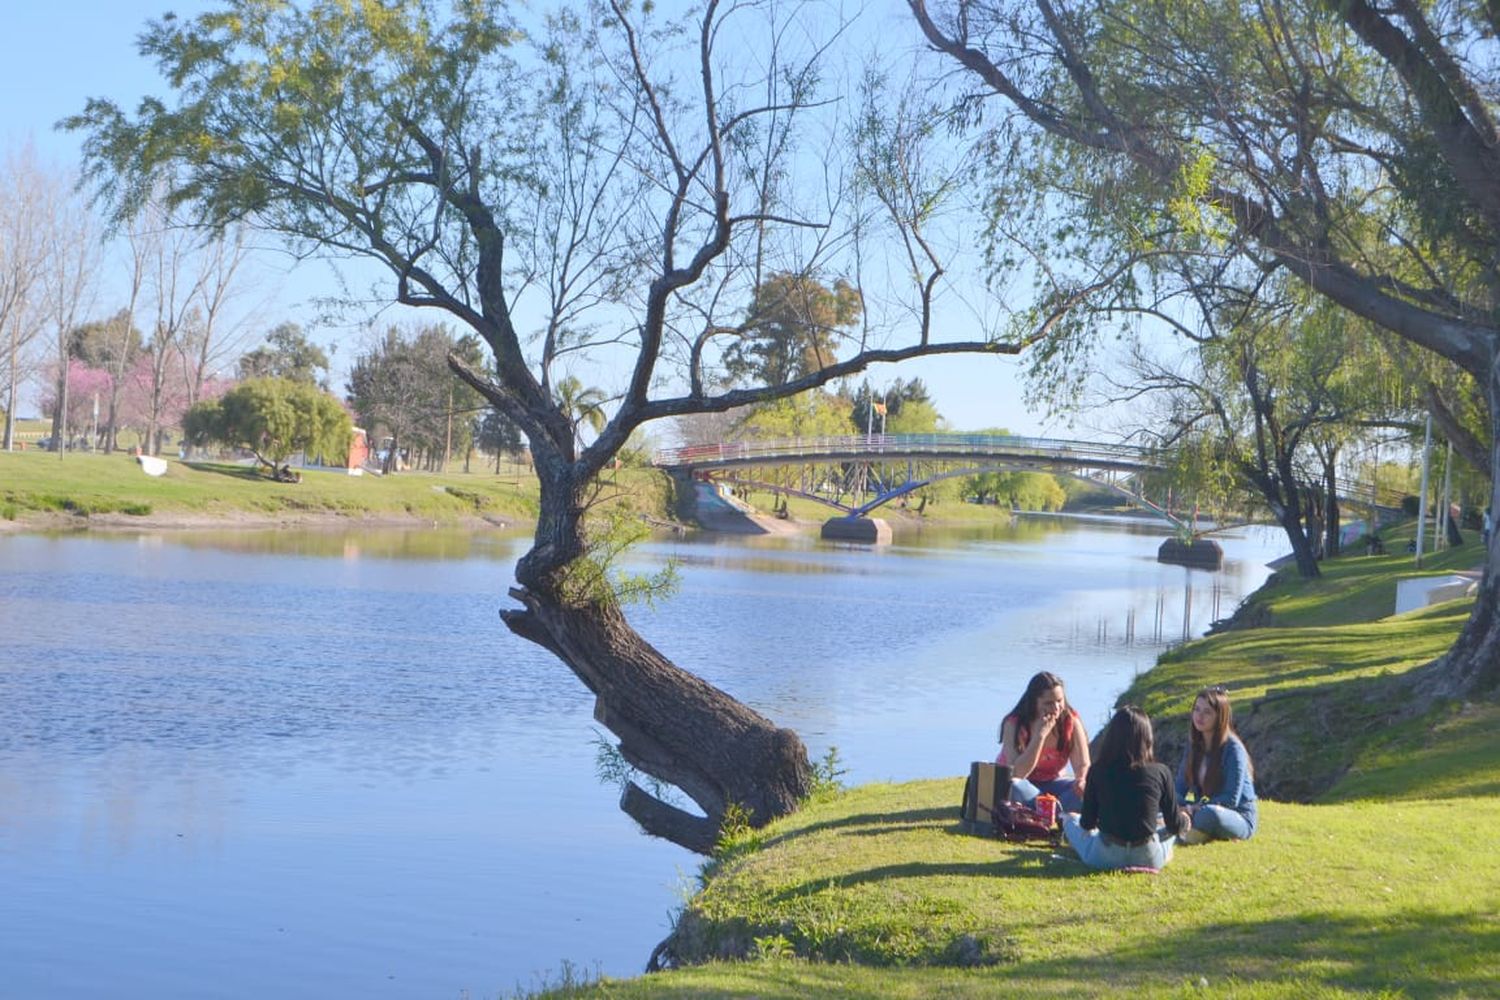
[1178,685,1257,844]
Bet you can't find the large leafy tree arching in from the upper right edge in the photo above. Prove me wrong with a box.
[908,0,1500,693]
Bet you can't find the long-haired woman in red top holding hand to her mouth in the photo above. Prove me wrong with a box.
[995,670,1089,810]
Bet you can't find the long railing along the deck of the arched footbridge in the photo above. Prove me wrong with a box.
[653,433,1155,468]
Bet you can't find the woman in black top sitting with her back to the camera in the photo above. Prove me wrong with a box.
[1062,705,1181,868]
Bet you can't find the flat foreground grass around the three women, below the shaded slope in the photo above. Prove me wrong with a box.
[555,780,1500,997]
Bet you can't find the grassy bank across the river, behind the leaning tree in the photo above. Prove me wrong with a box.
[0,451,671,526]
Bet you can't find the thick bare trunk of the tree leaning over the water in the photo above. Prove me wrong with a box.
[501,459,812,853]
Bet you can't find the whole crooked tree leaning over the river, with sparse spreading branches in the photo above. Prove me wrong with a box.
[69,0,1128,850]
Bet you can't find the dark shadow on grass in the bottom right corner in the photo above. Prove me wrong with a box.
[1013,910,1500,997]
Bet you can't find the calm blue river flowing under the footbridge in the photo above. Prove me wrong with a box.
[0,516,1280,1000]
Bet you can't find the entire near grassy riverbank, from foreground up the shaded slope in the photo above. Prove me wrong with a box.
[555,524,1500,997]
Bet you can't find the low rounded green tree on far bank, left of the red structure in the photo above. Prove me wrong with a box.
[183,378,353,481]
